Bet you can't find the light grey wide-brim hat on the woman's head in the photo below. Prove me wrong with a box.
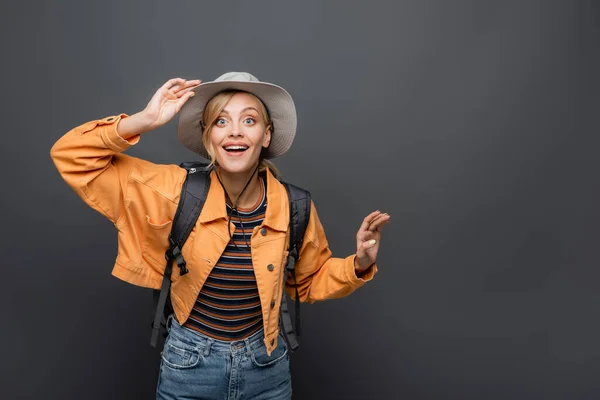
[177,72,297,159]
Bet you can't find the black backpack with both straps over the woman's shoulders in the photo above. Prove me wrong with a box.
[150,162,311,352]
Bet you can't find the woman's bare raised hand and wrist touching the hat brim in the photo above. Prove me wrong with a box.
[117,78,201,139]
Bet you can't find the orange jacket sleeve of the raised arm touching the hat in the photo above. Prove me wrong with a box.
[50,114,139,223]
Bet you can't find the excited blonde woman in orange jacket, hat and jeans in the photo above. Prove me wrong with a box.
[51,73,390,400]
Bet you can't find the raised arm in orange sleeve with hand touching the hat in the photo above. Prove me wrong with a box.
[50,79,200,223]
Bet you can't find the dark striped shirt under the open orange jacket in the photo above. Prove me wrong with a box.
[184,178,267,341]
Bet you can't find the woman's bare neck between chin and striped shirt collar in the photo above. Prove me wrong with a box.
[217,163,260,208]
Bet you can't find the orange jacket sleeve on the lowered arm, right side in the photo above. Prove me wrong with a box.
[286,203,377,303]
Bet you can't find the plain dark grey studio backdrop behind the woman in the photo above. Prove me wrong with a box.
[0,0,600,399]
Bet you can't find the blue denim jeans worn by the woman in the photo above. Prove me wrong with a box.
[156,318,292,400]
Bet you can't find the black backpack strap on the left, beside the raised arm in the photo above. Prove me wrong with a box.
[150,163,210,347]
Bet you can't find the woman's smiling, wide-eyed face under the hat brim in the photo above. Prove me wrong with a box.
[202,92,271,173]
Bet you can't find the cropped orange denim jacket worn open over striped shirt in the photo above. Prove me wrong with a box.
[51,114,377,354]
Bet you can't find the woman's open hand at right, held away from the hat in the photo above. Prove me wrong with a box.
[354,211,390,273]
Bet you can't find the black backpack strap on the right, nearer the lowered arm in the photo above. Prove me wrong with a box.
[281,182,311,352]
